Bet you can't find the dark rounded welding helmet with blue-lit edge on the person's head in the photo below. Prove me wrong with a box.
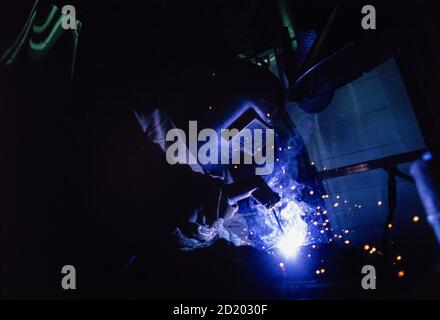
[161,60,284,175]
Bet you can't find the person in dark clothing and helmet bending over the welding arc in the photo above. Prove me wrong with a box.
[78,50,283,294]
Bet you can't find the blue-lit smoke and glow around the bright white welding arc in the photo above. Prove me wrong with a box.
[242,120,330,258]
